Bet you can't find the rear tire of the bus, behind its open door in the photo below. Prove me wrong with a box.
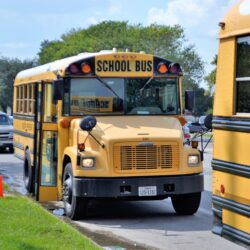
[23,150,34,193]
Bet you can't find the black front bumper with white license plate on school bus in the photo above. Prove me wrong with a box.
[73,174,204,199]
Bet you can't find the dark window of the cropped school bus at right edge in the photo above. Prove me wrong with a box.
[236,36,250,113]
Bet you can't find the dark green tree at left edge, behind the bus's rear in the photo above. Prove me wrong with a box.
[0,57,35,112]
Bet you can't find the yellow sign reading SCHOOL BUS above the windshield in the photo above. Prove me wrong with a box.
[95,53,153,77]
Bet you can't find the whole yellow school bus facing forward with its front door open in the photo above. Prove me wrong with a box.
[14,50,203,219]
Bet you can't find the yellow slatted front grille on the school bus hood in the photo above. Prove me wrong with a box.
[114,143,179,171]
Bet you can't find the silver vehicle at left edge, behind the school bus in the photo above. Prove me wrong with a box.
[0,112,14,153]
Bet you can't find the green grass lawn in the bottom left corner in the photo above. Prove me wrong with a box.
[0,195,100,250]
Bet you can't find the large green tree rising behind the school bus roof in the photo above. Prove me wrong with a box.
[38,21,204,90]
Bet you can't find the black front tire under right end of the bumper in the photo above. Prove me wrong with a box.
[171,192,201,215]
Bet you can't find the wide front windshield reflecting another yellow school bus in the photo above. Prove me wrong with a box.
[69,78,180,115]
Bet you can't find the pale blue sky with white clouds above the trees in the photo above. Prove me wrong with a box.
[0,0,240,86]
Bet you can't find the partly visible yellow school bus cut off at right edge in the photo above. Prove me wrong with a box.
[212,0,250,245]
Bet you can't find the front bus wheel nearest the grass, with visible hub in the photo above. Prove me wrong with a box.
[63,163,88,220]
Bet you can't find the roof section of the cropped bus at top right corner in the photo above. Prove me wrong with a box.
[219,0,250,38]
